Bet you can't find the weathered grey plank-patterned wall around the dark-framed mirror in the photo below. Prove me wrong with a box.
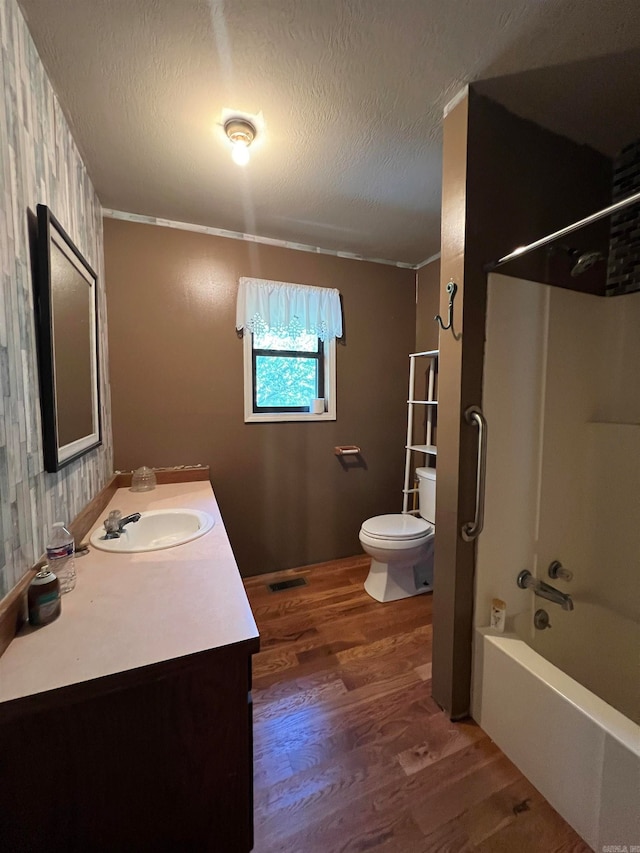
[0,0,113,598]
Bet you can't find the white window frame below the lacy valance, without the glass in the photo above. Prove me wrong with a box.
[243,329,336,423]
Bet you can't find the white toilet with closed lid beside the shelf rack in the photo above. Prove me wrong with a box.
[360,468,436,601]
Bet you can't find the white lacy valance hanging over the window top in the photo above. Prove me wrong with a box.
[236,278,342,341]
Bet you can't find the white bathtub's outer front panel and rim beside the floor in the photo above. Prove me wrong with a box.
[472,628,640,851]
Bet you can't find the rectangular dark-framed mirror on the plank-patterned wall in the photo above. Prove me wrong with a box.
[34,204,102,471]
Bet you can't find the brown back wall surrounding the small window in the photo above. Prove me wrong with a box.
[104,219,416,575]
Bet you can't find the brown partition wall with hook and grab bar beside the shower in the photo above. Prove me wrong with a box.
[433,89,611,717]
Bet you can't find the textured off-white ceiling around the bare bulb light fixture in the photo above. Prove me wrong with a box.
[20,0,640,264]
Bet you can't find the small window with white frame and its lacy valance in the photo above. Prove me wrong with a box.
[236,279,342,422]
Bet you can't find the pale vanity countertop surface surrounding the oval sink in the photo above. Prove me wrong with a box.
[0,482,258,702]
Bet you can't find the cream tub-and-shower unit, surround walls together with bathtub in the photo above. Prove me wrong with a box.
[473,274,640,849]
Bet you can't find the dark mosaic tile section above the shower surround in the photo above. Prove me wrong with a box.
[607,139,640,296]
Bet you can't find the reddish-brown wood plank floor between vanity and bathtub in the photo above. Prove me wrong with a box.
[245,556,590,853]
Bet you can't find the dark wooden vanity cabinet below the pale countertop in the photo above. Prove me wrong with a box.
[0,638,258,853]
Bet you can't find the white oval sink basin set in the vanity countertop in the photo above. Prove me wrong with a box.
[89,509,215,554]
